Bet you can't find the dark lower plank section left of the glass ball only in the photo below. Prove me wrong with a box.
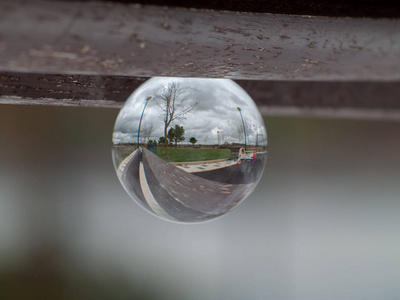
[0,72,148,107]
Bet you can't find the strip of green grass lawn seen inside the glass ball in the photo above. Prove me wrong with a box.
[156,147,231,162]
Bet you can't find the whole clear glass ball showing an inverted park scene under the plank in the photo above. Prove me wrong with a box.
[112,77,267,223]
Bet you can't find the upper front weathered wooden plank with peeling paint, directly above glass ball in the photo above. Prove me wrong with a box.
[0,0,400,81]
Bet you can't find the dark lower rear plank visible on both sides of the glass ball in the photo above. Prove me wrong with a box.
[0,72,400,120]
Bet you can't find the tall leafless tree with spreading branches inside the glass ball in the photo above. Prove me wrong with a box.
[154,82,198,157]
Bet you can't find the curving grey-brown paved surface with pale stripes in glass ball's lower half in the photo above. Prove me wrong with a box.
[118,148,264,222]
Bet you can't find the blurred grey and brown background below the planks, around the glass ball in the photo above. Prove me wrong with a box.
[0,105,400,300]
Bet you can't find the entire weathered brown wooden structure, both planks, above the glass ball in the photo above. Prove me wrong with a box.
[0,0,400,119]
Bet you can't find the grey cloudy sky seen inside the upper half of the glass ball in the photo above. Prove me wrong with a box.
[113,77,267,145]
